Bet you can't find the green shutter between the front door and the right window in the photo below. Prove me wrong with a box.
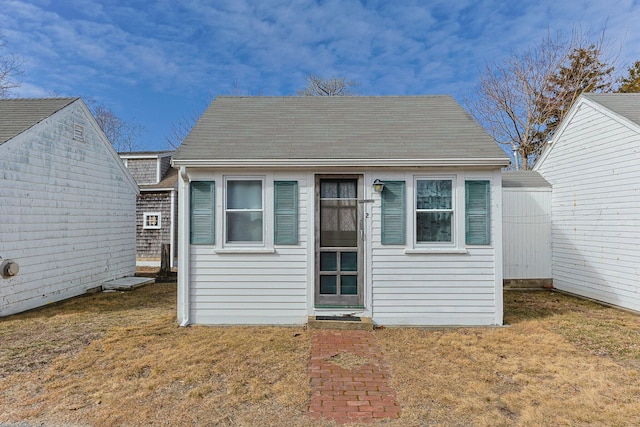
[381,181,407,245]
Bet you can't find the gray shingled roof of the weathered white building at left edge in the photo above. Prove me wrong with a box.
[0,98,79,145]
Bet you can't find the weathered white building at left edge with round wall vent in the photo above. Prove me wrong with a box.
[0,98,138,316]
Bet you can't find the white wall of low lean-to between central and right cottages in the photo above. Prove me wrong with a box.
[502,188,552,279]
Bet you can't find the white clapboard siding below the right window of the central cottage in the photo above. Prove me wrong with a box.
[372,247,496,325]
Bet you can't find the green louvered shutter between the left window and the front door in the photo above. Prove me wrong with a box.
[273,181,298,245]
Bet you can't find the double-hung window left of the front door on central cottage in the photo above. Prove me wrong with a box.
[224,176,265,246]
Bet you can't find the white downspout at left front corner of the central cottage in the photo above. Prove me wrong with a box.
[178,166,190,326]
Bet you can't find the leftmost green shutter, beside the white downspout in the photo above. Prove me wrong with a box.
[190,181,216,245]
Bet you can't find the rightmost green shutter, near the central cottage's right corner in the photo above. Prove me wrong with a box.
[465,181,491,245]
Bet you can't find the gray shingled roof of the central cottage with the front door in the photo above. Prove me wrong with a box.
[173,96,508,165]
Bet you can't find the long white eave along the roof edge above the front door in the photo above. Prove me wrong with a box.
[171,157,510,169]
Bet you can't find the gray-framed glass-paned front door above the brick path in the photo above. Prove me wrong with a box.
[315,175,364,308]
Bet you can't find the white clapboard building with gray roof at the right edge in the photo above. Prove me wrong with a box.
[534,94,640,311]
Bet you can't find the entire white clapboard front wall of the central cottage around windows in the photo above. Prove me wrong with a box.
[179,170,502,325]
